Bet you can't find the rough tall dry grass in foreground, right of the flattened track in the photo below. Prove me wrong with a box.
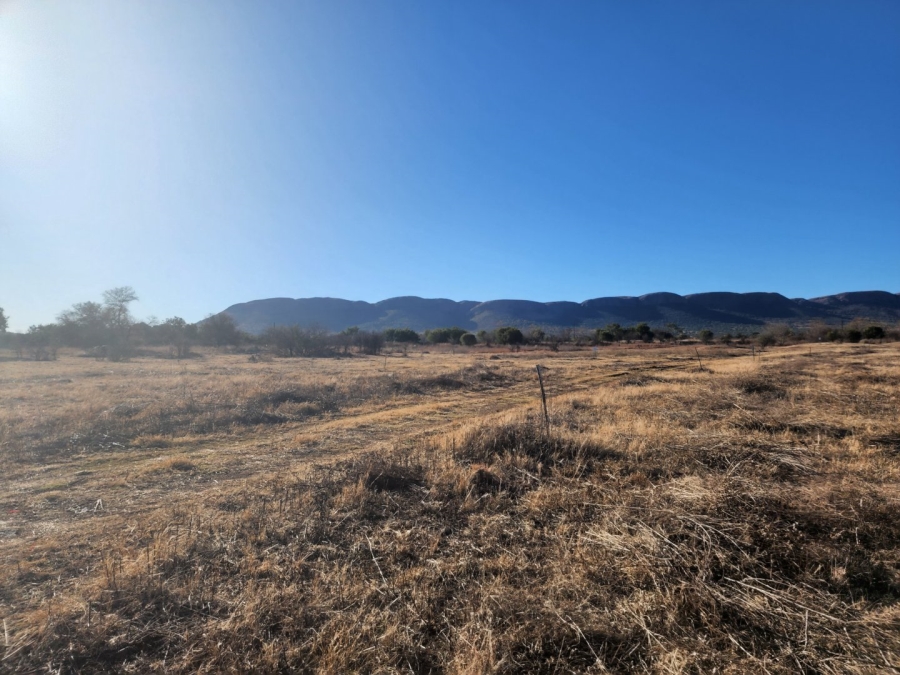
[0,346,900,673]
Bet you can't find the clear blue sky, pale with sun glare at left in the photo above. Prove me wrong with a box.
[0,0,900,330]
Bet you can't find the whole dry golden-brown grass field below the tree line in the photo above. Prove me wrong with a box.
[0,344,900,674]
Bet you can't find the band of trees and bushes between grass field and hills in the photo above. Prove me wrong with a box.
[0,294,900,360]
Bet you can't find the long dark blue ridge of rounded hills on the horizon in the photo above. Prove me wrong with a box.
[224,291,900,334]
